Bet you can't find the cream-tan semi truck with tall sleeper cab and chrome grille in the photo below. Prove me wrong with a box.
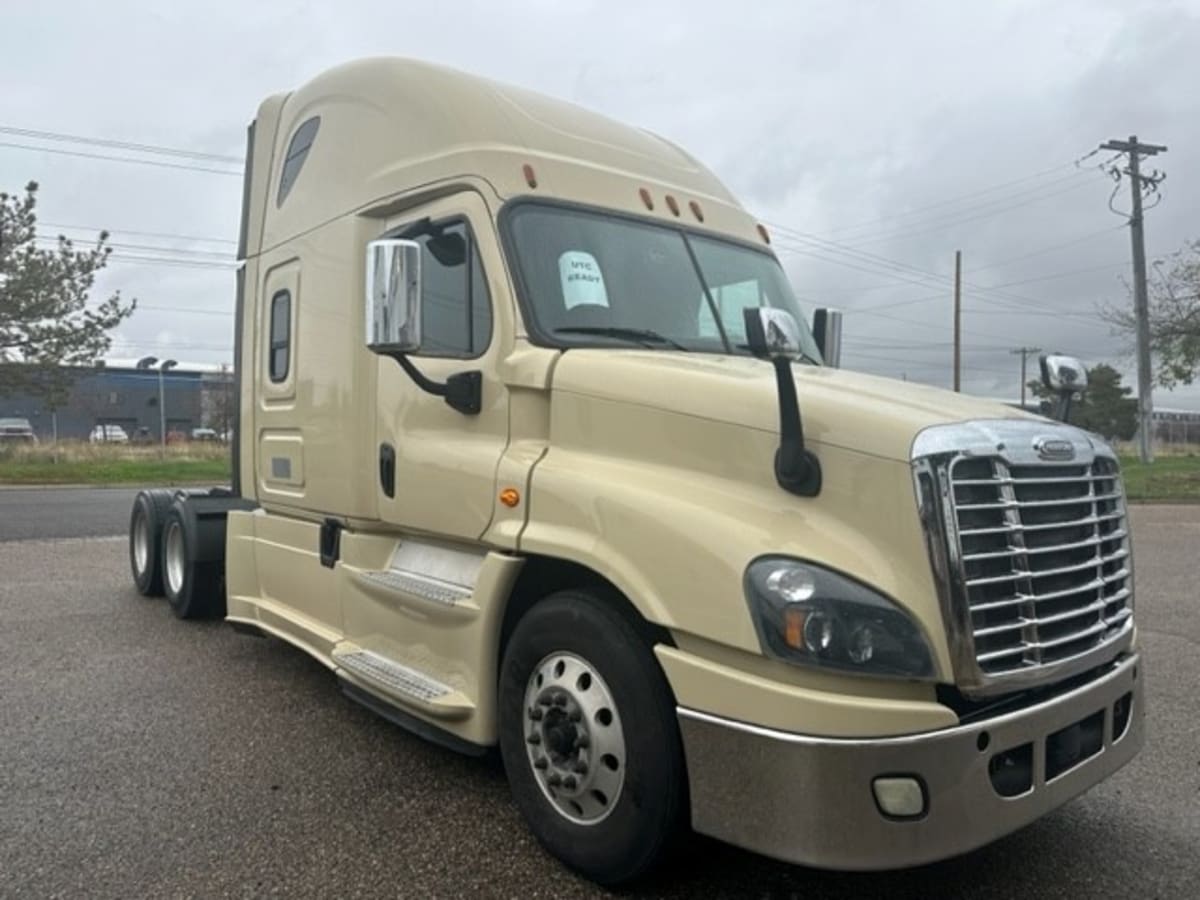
[130,59,1142,883]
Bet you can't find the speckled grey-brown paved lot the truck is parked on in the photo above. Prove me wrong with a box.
[0,504,1200,900]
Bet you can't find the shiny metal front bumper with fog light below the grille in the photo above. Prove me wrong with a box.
[679,654,1144,870]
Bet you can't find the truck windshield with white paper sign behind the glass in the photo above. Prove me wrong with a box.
[509,204,820,361]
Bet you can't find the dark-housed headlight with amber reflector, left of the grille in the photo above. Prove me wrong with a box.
[745,557,934,678]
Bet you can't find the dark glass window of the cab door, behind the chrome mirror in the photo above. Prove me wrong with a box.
[415,221,492,358]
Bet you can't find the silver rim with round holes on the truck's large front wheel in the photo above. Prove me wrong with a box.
[522,653,626,826]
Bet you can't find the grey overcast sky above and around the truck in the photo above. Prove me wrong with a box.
[0,0,1200,409]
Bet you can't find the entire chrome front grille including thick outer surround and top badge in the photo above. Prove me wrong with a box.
[912,420,1134,696]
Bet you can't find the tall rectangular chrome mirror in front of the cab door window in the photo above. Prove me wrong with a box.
[366,240,421,353]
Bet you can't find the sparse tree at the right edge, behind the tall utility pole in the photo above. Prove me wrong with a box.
[1102,241,1200,388]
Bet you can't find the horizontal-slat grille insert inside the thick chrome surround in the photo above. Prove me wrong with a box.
[947,455,1133,676]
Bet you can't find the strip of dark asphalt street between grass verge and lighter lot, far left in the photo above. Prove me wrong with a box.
[0,487,137,541]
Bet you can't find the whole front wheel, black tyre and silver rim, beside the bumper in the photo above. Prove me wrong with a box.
[499,590,686,884]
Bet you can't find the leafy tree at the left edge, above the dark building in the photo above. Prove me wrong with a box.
[0,181,137,406]
